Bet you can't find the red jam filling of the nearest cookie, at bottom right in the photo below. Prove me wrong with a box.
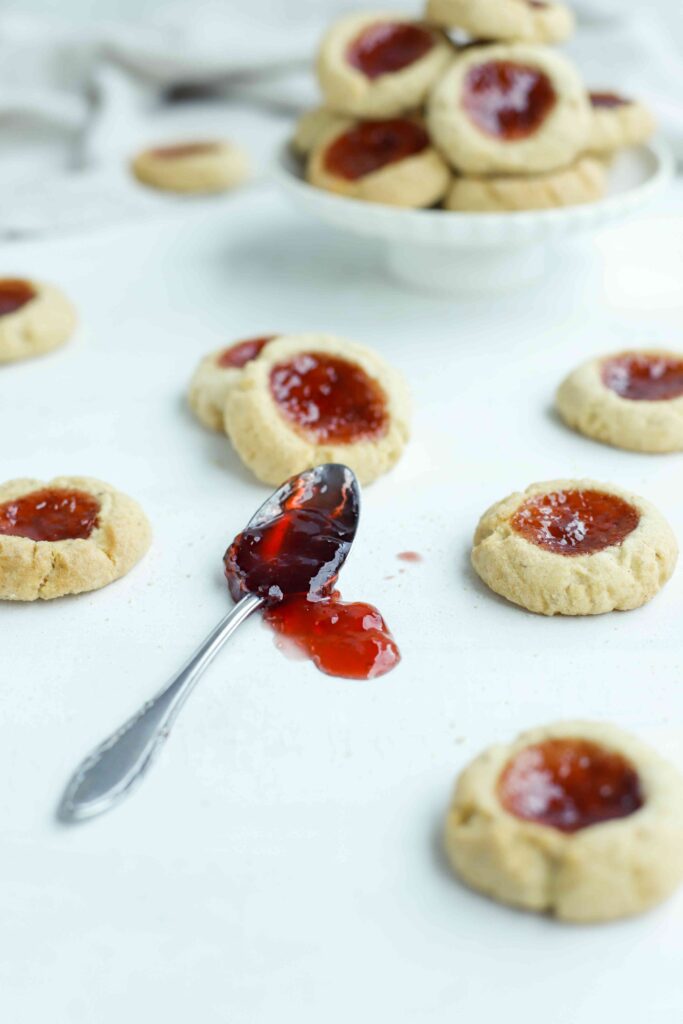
[498,738,643,833]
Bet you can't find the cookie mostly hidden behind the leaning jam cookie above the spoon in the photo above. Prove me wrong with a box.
[188,335,275,431]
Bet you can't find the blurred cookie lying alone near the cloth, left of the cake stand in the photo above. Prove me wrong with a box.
[131,140,250,194]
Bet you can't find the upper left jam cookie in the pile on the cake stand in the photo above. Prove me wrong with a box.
[317,12,454,118]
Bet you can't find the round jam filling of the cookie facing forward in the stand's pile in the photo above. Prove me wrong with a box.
[462,60,557,142]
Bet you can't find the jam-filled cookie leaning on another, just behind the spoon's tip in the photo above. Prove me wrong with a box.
[225,334,411,484]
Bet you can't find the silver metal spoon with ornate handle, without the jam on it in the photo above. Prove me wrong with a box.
[57,463,359,822]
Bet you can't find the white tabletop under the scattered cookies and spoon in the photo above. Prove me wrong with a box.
[0,169,683,1024]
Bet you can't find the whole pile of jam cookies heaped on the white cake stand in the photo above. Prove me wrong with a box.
[292,0,653,212]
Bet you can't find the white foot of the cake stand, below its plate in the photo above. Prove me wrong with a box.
[386,243,546,293]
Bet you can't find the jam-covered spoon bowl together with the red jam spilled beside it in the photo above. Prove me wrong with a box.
[224,465,400,679]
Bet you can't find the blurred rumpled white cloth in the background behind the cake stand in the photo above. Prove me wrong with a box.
[0,0,683,237]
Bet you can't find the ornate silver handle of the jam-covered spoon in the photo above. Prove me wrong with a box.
[57,594,263,821]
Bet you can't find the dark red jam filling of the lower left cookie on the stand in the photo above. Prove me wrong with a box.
[324,118,429,181]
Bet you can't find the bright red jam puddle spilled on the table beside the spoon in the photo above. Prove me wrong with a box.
[265,594,400,679]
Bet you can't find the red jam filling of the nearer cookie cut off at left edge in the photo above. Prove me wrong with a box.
[0,487,99,541]
